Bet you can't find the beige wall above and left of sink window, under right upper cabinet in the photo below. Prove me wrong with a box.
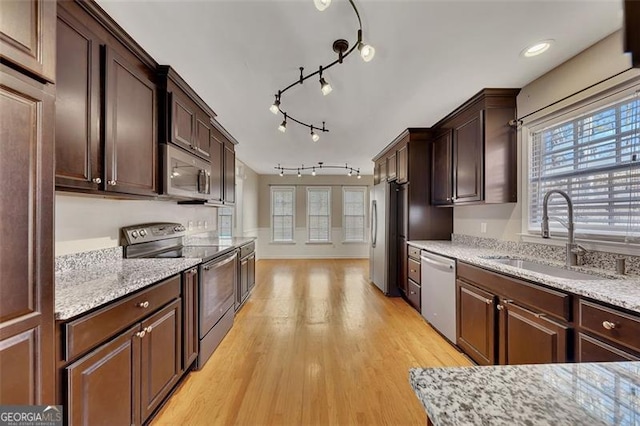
[453,31,631,241]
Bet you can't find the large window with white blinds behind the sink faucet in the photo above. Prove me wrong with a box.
[528,95,640,241]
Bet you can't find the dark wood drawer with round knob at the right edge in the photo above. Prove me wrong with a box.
[578,300,640,352]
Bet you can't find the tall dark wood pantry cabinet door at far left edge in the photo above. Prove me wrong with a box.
[0,68,54,405]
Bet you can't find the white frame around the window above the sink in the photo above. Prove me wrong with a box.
[520,77,640,245]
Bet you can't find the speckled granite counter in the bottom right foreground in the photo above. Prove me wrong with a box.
[409,362,640,426]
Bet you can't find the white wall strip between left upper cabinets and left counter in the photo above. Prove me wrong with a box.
[55,193,217,256]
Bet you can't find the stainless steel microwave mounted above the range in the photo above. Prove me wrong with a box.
[162,144,211,200]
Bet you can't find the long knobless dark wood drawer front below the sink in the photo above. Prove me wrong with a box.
[457,262,571,321]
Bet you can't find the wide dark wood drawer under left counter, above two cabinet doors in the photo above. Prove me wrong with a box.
[64,275,180,361]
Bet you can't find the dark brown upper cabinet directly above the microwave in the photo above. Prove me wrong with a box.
[158,65,216,160]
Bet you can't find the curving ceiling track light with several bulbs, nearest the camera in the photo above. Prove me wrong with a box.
[269,0,376,138]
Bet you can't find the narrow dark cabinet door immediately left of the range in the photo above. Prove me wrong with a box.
[182,268,198,370]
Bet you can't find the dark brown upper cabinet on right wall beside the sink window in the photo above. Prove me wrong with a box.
[431,89,520,205]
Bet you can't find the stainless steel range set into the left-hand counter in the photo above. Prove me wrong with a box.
[120,223,238,369]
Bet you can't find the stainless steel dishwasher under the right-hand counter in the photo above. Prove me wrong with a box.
[420,250,457,343]
